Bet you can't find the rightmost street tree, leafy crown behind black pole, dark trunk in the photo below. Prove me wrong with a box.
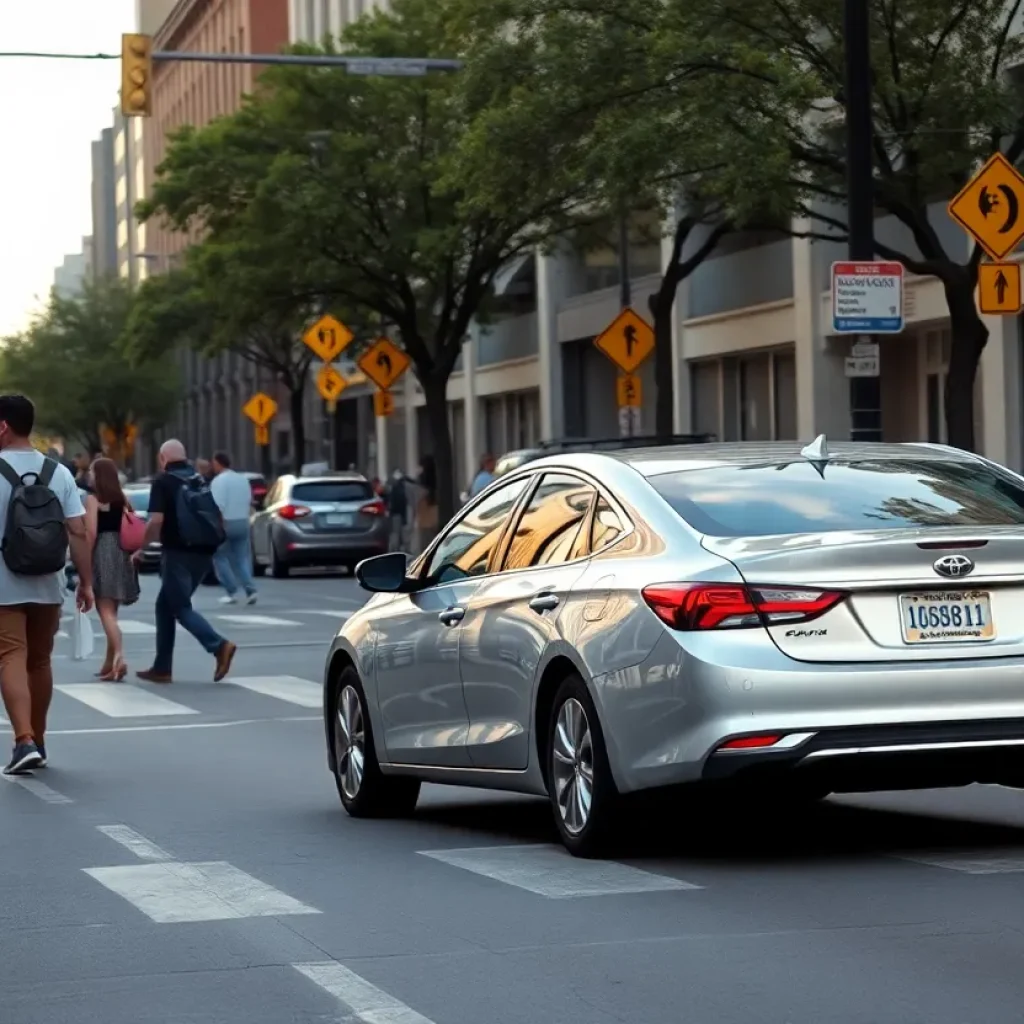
[671,0,1024,449]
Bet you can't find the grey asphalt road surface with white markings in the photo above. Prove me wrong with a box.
[6,577,1024,1024]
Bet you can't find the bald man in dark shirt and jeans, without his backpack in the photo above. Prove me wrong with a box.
[136,440,238,683]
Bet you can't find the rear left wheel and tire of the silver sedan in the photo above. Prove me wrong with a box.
[545,673,621,857]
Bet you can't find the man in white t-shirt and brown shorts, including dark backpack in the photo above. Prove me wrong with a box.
[0,394,93,775]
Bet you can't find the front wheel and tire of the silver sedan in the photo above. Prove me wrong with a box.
[330,666,420,818]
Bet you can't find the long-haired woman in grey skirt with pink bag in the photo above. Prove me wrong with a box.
[85,458,139,683]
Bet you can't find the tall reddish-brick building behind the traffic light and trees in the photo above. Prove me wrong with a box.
[135,0,288,469]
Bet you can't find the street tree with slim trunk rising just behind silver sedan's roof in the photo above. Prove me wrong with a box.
[457,0,794,436]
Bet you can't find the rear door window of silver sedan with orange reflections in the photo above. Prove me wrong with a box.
[502,473,594,570]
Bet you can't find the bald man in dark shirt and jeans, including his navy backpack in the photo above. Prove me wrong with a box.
[136,440,237,683]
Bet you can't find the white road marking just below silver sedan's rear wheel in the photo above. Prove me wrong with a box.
[418,844,701,899]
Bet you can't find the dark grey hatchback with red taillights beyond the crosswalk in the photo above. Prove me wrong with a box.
[252,473,389,578]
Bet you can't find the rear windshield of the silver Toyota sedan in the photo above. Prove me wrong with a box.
[648,459,1024,537]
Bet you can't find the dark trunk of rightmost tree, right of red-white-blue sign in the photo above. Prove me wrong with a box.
[943,267,988,452]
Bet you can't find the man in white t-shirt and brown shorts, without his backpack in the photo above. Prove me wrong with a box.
[0,394,93,775]
